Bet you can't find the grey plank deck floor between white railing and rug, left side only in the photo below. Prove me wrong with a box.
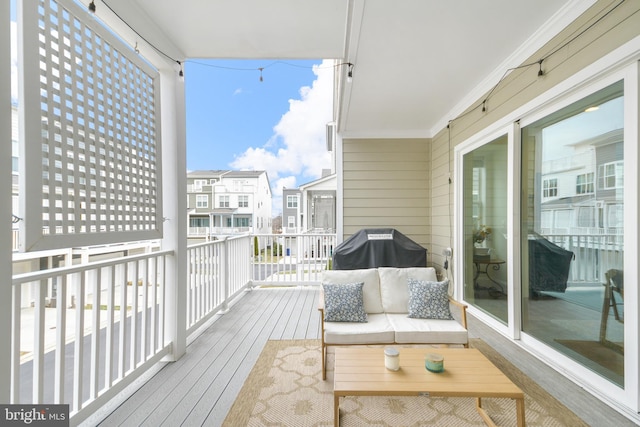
[100,287,319,426]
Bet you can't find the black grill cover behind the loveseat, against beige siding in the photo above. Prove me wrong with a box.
[333,228,427,270]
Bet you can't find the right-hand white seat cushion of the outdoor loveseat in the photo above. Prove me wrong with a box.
[386,314,468,344]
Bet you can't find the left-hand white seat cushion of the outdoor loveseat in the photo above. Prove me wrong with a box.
[324,314,394,344]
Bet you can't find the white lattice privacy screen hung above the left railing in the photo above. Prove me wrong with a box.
[20,0,162,251]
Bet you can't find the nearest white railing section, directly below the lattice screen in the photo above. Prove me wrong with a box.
[11,251,173,424]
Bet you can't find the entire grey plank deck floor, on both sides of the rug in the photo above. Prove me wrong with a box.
[101,286,635,427]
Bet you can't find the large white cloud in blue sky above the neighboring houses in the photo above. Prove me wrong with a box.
[230,61,334,211]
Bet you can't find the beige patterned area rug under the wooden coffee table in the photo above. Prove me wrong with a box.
[223,339,586,427]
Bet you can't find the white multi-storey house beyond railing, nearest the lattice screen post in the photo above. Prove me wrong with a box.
[187,170,271,239]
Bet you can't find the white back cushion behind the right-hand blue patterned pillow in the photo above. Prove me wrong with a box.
[378,267,438,313]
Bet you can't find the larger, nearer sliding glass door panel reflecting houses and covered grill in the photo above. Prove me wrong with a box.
[520,82,625,386]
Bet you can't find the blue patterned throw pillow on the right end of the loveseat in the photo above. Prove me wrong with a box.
[408,279,453,320]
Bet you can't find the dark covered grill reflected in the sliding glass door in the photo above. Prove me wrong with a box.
[529,236,573,293]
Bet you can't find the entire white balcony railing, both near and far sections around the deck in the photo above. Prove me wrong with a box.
[11,234,336,425]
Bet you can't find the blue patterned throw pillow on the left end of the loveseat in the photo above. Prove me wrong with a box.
[322,283,367,323]
